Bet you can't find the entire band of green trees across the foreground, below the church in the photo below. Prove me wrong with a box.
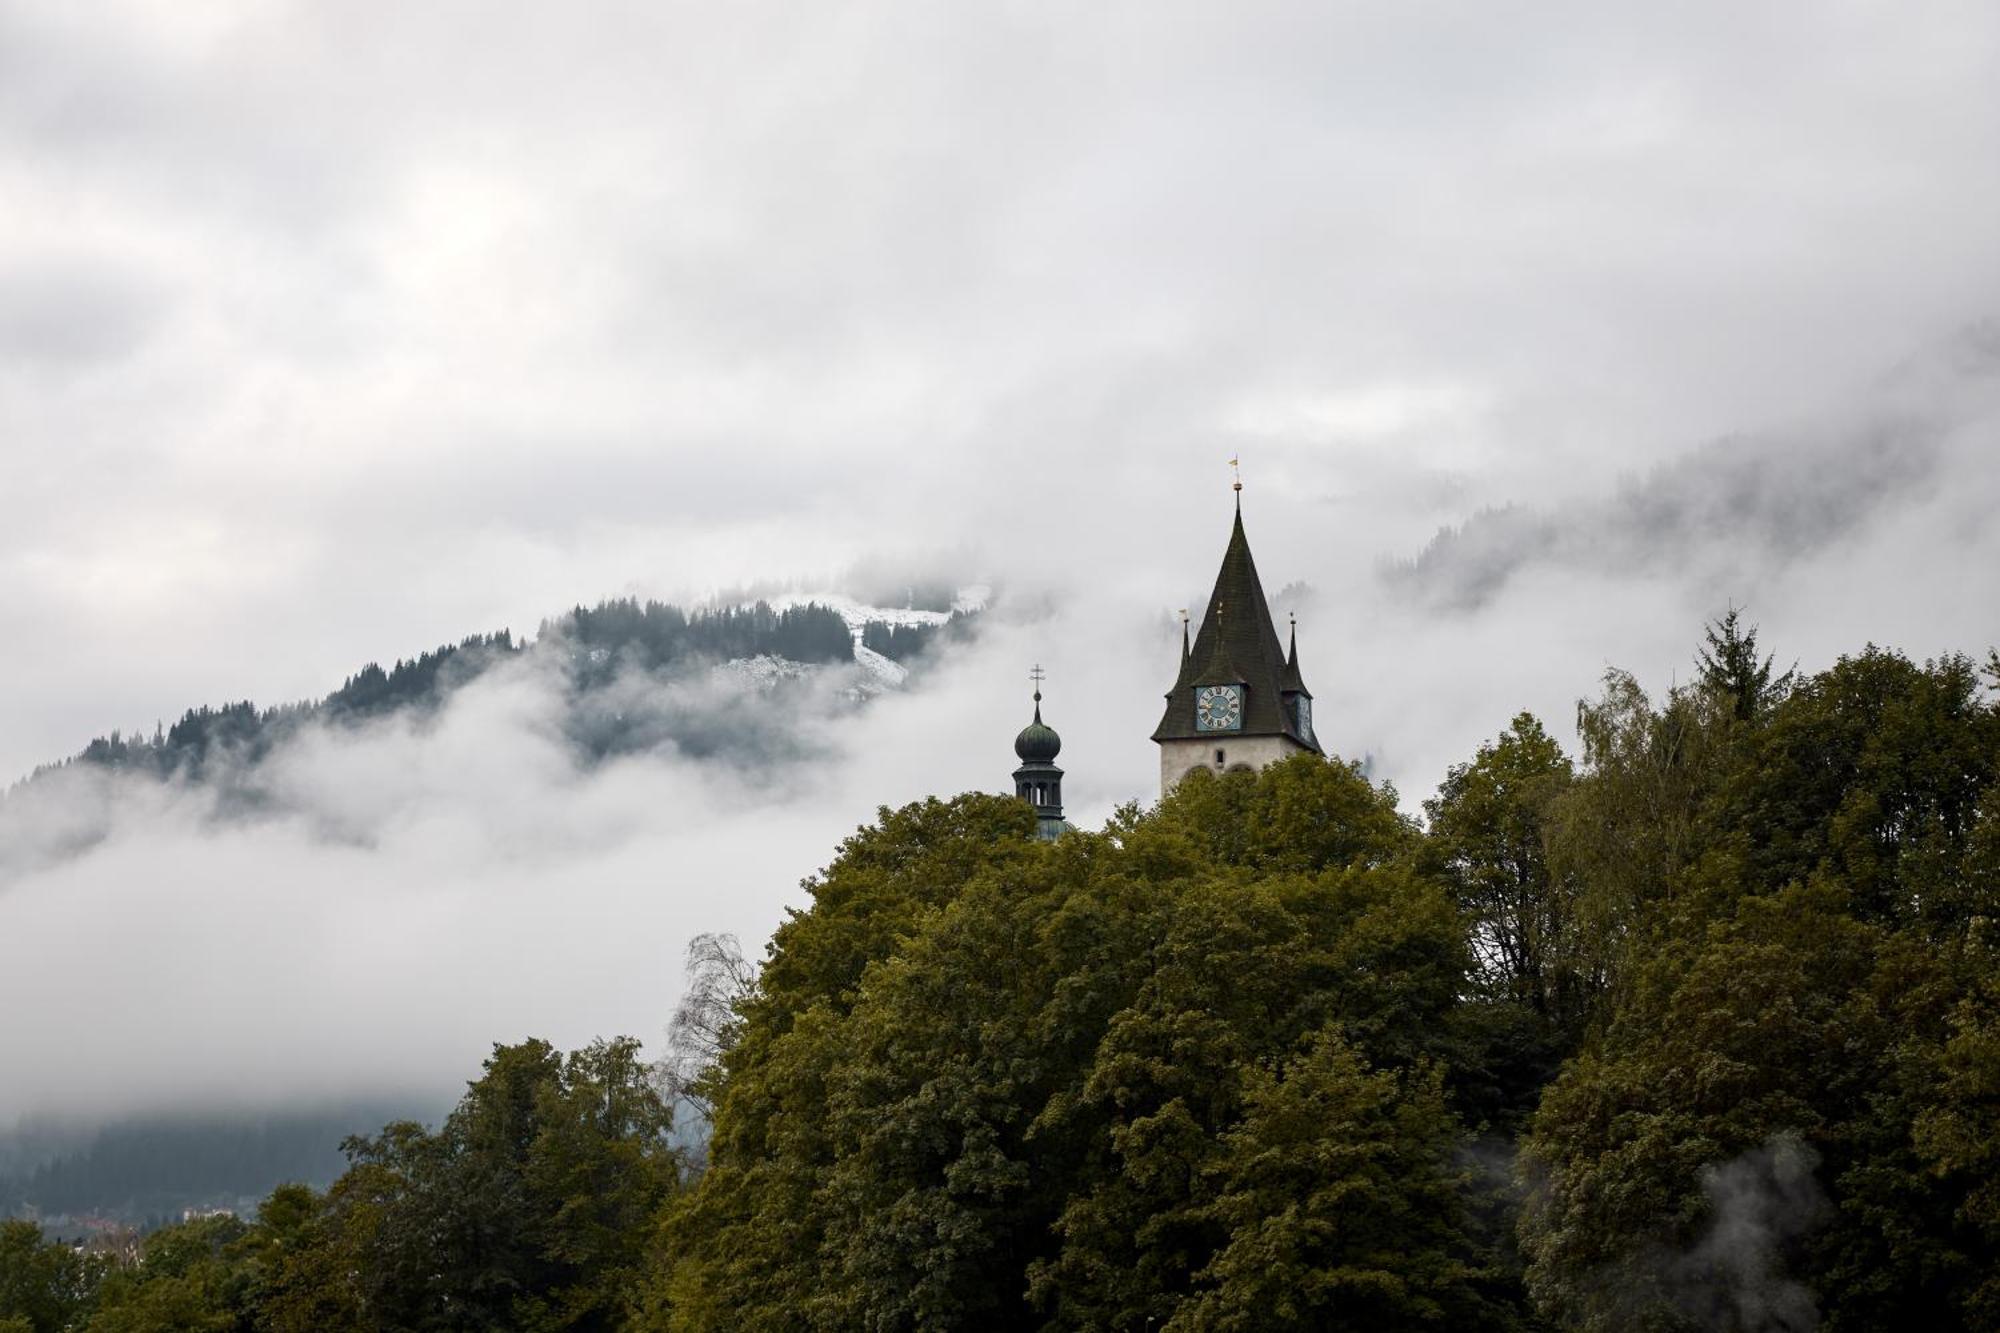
[0,616,2000,1331]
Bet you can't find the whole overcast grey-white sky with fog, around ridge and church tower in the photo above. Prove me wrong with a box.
[0,0,2000,1117]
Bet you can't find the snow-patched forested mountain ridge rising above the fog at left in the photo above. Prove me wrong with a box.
[0,596,978,877]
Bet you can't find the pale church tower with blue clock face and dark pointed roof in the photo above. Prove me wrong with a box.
[1152,480,1322,797]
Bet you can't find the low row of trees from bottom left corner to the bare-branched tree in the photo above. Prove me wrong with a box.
[0,1041,678,1333]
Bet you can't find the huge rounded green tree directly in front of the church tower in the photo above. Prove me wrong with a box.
[648,757,1496,1329]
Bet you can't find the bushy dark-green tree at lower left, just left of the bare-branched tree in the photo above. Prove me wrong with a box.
[264,1037,678,1329]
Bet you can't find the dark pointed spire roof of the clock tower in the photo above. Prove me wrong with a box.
[1152,506,1320,753]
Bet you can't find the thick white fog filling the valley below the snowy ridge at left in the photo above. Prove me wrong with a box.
[0,612,1032,1123]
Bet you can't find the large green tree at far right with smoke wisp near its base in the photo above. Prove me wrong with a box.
[1522,650,2000,1329]
